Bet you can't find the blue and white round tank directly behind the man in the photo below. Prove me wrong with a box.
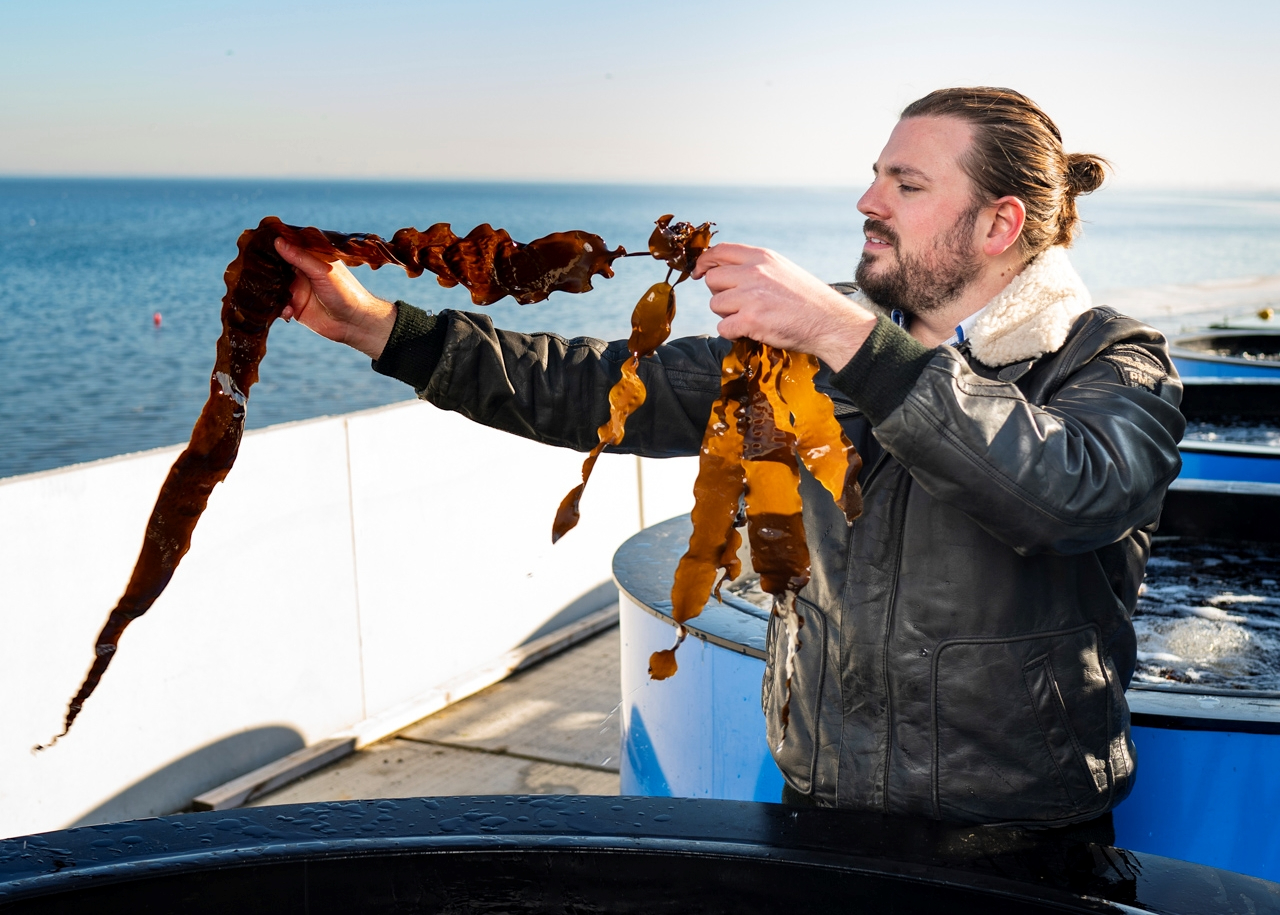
[613,496,1280,880]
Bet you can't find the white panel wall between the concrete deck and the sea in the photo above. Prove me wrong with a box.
[0,402,695,836]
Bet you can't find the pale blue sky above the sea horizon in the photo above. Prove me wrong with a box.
[0,0,1280,188]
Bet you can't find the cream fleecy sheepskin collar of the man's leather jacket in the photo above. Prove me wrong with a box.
[859,246,1093,369]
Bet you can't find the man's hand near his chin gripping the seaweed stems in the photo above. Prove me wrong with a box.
[692,243,876,371]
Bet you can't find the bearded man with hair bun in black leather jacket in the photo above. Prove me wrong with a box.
[280,88,1183,825]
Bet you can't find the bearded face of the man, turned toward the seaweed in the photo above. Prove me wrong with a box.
[855,118,982,315]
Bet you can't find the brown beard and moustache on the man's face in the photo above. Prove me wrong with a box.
[854,206,982,316]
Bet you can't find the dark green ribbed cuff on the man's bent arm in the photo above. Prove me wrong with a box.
[831,316,933,426]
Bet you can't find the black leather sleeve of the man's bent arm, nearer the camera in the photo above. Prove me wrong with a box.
[842,315,1185,555]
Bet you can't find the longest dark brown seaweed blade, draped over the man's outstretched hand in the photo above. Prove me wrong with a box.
[35,216,624,750]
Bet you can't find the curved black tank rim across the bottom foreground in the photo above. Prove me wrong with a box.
[0,796,1280,915]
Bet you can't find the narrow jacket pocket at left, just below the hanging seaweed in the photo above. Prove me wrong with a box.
[760,599,827,793]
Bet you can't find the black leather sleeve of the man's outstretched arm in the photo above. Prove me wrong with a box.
[419,311,728,457]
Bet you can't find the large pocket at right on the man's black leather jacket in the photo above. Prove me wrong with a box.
[933,626,1117,824]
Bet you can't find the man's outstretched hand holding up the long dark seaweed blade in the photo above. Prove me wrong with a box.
[275,238,396,360]
